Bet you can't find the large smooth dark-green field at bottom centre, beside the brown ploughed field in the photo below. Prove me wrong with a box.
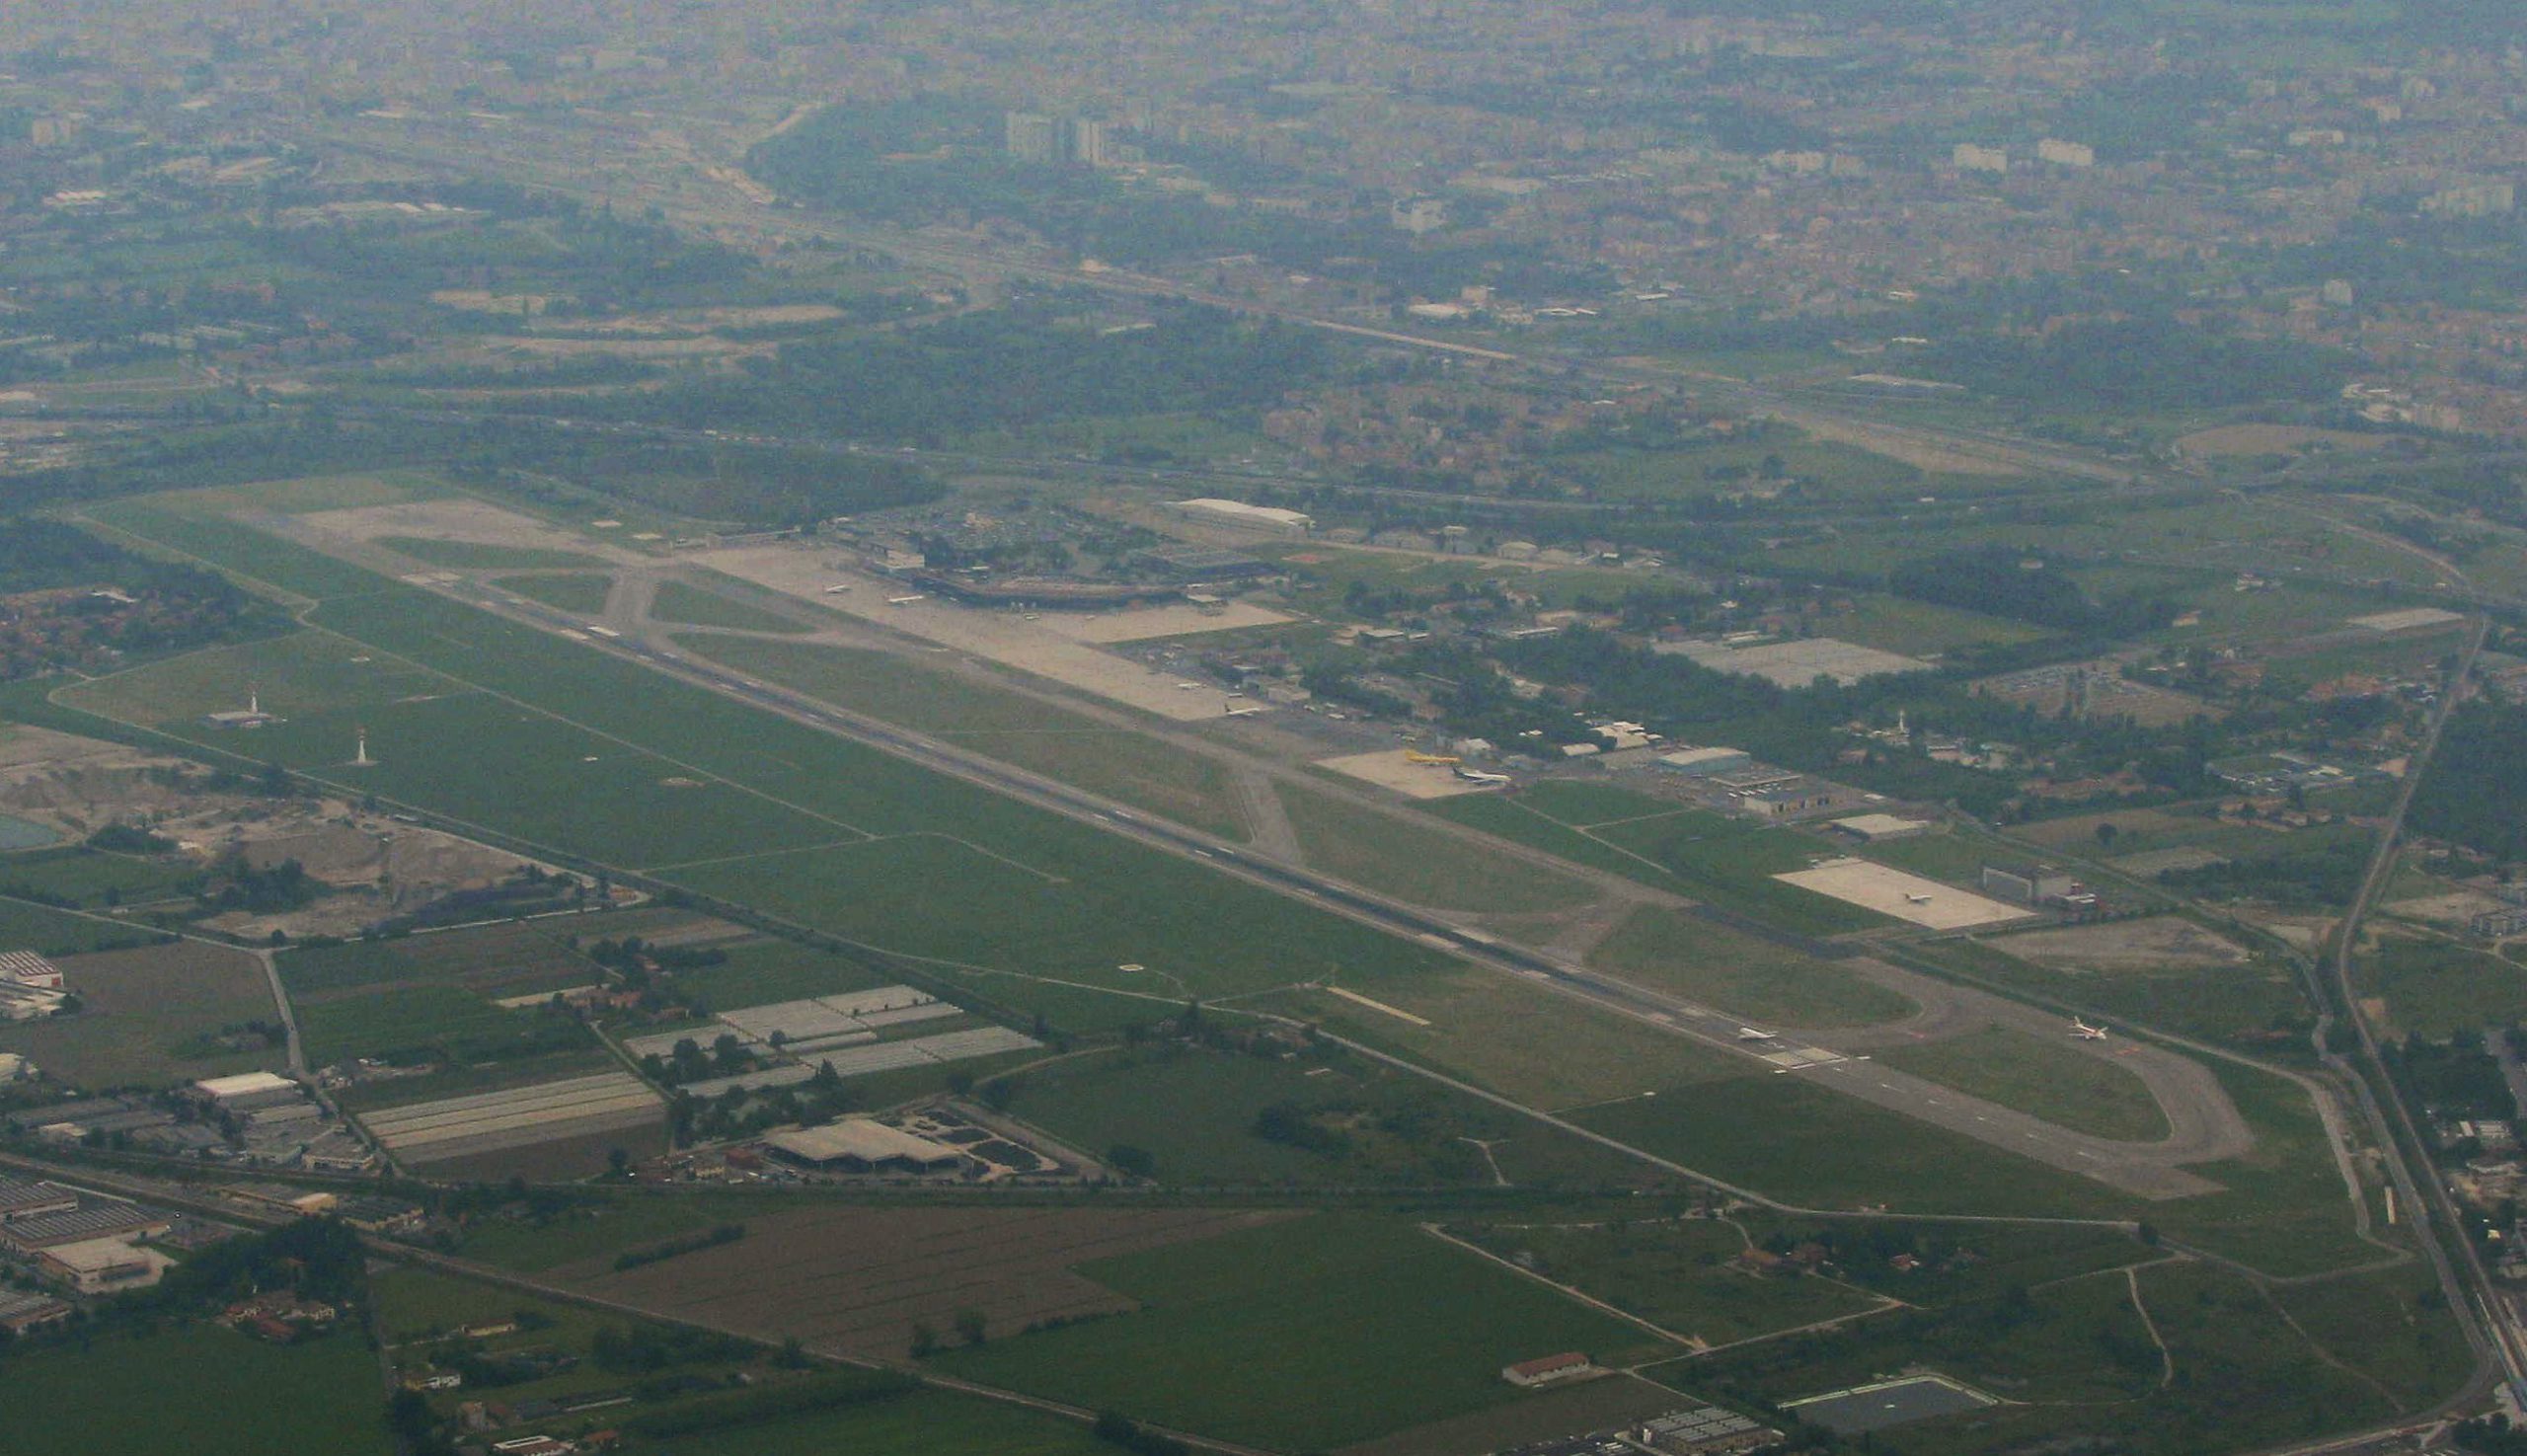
[938,1213,1660,1451]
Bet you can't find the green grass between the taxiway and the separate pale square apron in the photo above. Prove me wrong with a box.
[1427,781,1887,935]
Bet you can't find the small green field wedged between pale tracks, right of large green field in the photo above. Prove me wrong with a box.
[1450,1218,1892,1344]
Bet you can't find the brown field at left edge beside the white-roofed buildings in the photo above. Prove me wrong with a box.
[0,930,288,1090]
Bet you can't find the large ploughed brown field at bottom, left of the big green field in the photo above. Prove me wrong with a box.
[561,1208,1289,1357]
